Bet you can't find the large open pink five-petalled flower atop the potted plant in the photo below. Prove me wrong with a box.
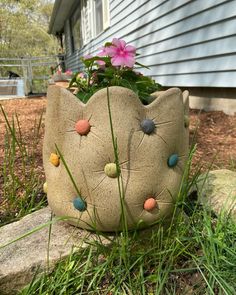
[106,38,136,68]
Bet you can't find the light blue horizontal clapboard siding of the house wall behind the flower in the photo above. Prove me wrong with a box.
[62,0,236,87]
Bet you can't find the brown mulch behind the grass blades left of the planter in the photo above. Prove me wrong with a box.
[0,97,46,206]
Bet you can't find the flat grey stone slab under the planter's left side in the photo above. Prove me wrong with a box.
[0,208,101,295]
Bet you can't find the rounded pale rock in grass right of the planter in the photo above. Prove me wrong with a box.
[196,169,236,221]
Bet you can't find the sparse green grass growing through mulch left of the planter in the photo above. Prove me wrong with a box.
[0,105,46,226]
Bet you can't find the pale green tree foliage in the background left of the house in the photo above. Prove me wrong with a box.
[0,0,57,76]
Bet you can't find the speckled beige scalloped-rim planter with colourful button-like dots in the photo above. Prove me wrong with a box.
[43,85,189,231]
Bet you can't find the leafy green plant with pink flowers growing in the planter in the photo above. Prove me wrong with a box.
[69,38,161,104]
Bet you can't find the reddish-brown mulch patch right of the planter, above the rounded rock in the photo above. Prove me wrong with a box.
[190,110,236,170]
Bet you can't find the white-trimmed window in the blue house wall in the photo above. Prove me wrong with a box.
[71,0,110,50]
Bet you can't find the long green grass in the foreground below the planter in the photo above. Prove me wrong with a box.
[20,204,236,295]
